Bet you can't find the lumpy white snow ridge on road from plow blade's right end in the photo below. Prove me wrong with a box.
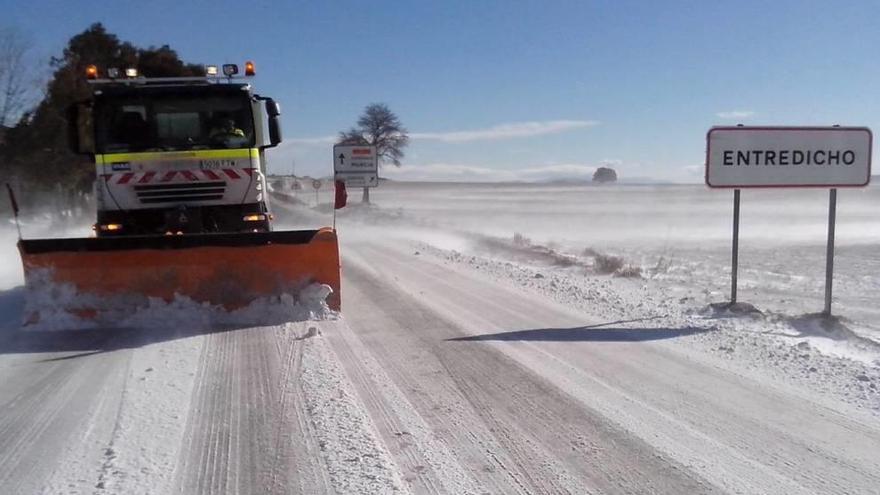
[302,327,409,493]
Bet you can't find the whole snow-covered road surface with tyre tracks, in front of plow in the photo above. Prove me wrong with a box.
[0,241,880,494]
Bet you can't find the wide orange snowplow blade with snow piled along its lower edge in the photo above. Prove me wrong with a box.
[19,229,340,328]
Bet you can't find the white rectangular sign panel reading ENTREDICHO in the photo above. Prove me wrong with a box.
[706,126,872,189]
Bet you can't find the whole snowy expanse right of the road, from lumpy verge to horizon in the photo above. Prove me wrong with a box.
[276,183,880,413]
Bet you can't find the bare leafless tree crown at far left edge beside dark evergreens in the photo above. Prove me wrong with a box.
[0,27,38,126]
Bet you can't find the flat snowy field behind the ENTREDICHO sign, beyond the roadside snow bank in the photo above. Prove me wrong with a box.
[330,183,880,352]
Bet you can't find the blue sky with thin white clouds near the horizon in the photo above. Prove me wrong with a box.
[0,0,880,181]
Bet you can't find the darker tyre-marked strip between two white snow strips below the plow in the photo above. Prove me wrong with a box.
[175,326,330,494]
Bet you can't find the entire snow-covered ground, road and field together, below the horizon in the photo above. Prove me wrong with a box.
[0,183,880,494]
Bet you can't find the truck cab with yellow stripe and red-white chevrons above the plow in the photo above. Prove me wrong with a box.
[72,63,281,237]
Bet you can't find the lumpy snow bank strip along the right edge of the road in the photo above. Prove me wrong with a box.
[415,242,880,415]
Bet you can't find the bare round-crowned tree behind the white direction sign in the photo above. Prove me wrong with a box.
[339,103,409,203]
